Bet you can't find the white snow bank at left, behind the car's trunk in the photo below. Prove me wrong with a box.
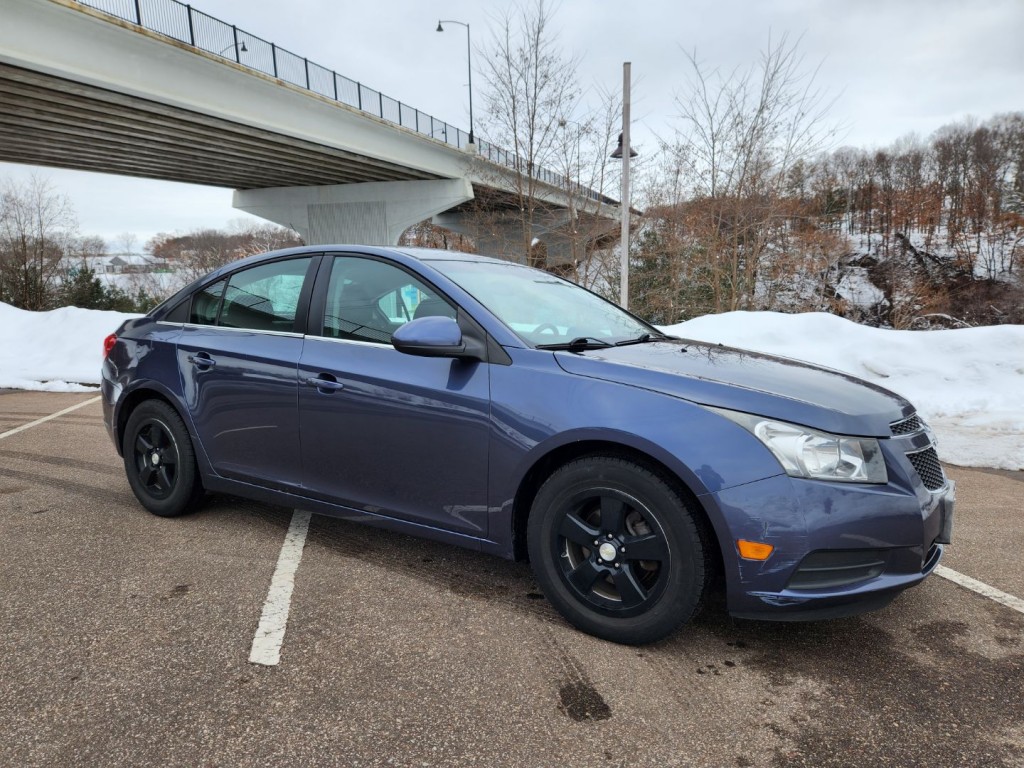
[0,303,137,392]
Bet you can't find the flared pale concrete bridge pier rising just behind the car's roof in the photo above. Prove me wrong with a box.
[232,178,473,246]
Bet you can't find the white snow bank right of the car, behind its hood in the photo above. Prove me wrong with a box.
[666,312,1024,469]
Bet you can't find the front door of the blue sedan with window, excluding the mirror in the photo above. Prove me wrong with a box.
[299,255,489,536]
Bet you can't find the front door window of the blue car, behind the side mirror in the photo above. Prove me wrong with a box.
[324,256,456,344]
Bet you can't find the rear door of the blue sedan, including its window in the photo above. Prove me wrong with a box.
[177,256,319,489]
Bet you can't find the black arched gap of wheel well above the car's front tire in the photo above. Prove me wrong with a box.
[512,440,725,578]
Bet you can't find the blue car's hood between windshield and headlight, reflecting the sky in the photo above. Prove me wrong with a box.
[555,339,913,437]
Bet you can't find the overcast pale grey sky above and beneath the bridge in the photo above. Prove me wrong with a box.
[0,0,1024,247]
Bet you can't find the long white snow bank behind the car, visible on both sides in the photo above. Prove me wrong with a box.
[0,304,1024,469]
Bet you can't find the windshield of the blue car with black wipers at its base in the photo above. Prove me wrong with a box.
[431,261,662,347]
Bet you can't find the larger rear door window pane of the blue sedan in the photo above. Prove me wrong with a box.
[224,257,312,331]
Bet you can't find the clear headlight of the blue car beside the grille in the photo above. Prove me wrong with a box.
[710,408,889,482]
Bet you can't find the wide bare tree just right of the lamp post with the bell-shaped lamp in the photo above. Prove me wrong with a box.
[641,36,837,311]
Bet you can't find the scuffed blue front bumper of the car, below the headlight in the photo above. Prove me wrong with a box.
[714,475,955,621]
